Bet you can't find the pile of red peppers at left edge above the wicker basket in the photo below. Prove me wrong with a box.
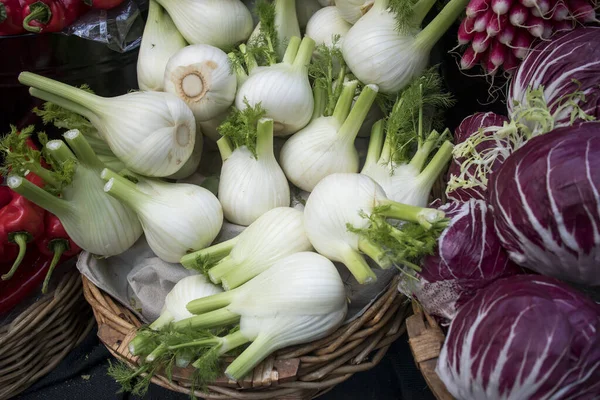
[0,130,81,314]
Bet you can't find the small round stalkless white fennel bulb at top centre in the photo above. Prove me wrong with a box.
[306,6,352,47]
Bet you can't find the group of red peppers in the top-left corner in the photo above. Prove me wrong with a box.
[0,0,124,36]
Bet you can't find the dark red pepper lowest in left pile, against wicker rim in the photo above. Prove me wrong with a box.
[0,247,52,314]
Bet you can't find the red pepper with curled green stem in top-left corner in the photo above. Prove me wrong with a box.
[23,0,89,33]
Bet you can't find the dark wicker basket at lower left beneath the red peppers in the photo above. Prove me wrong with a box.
[0,268,95,399]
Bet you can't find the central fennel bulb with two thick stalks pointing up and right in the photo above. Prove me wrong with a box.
[280,81,377,192]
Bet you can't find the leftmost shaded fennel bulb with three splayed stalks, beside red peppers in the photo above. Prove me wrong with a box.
[7,130,142,257]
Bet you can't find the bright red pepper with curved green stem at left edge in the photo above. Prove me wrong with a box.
[0,178,46,280]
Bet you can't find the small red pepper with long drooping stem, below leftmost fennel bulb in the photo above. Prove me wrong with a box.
[36,213,81,293]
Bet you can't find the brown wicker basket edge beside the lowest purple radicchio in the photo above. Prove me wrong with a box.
[406,306,454,400]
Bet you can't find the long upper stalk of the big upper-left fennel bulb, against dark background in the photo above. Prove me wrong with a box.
[19,72,103,112]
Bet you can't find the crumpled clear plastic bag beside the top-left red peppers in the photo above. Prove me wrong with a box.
[63,0,148,53]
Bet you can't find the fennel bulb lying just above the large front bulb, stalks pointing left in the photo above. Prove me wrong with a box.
[181,207,312,290]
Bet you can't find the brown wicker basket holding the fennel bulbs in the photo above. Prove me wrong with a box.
[83,277,409,400]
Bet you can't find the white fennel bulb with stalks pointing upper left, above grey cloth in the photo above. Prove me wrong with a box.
[102,169,223,263]
